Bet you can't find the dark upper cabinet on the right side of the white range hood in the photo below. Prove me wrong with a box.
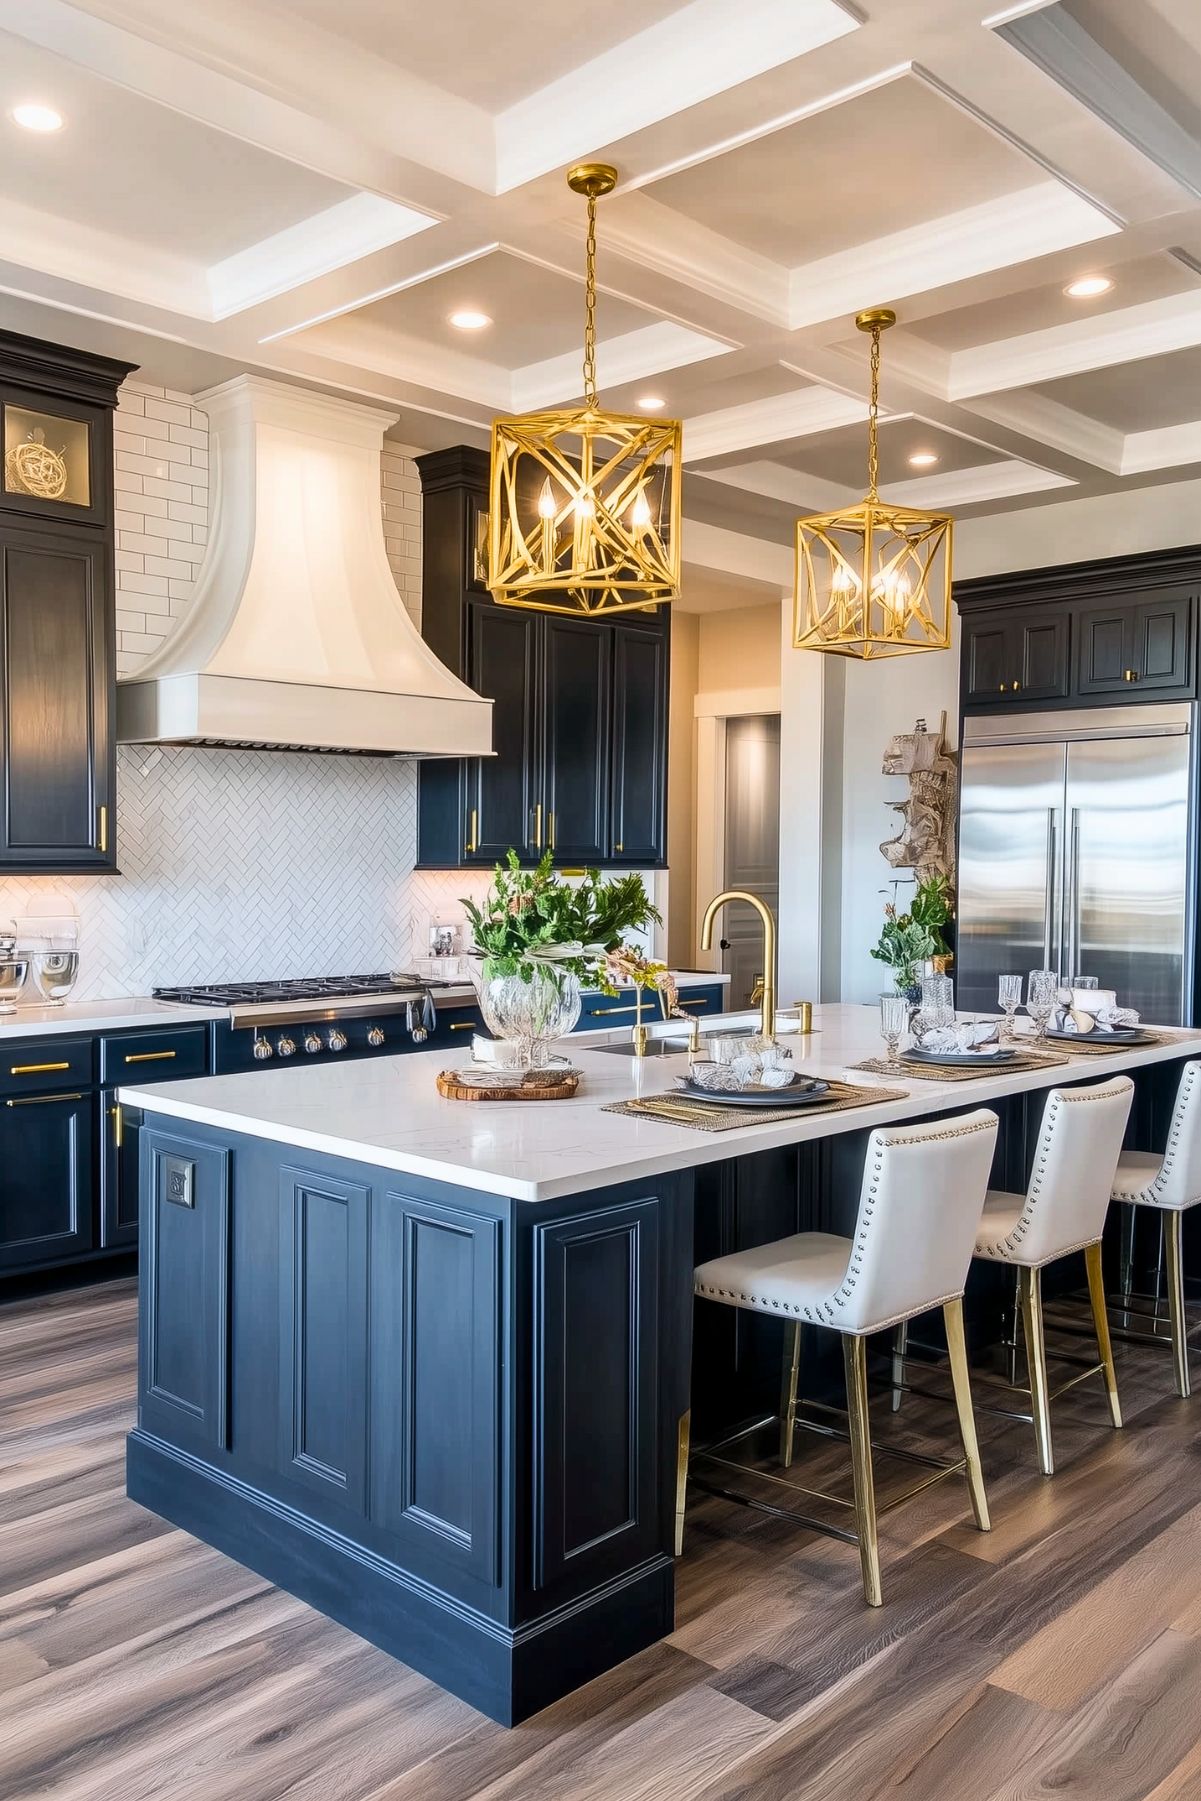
[418,447,670,868]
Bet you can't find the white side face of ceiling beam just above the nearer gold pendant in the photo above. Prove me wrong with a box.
[497,0,859,193]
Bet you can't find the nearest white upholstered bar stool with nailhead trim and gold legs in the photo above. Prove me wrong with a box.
[691,1109,998,1606]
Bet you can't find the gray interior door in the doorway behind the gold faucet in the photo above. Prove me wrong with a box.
[722,713,780,1007]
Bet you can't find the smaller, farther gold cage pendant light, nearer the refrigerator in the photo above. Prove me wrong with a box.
[792,306,951,659]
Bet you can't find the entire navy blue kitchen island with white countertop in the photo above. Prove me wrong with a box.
[122,1007,1201,1722]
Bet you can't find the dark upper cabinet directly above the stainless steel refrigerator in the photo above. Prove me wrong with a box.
[954,546,1201,711]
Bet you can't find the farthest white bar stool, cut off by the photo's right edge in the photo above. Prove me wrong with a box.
[1113,1063,1201,1398]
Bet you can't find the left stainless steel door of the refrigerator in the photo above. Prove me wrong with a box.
[956,744,1066,1012]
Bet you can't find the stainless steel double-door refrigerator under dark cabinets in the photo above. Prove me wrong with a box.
[956,704,1196,1025]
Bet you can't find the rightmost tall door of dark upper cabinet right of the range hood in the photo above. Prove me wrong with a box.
[610,625,668,866]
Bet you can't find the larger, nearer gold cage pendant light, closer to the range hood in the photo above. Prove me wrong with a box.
[488,162,681,614]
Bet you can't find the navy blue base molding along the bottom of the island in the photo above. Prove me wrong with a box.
[126,1430,675,1725]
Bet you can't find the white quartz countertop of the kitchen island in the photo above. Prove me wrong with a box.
[121,1007,1201,1201]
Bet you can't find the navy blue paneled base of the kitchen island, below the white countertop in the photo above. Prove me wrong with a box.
[128,1113,691,1724]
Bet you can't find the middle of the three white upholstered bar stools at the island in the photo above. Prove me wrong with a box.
[976,1075,1134,1475]
